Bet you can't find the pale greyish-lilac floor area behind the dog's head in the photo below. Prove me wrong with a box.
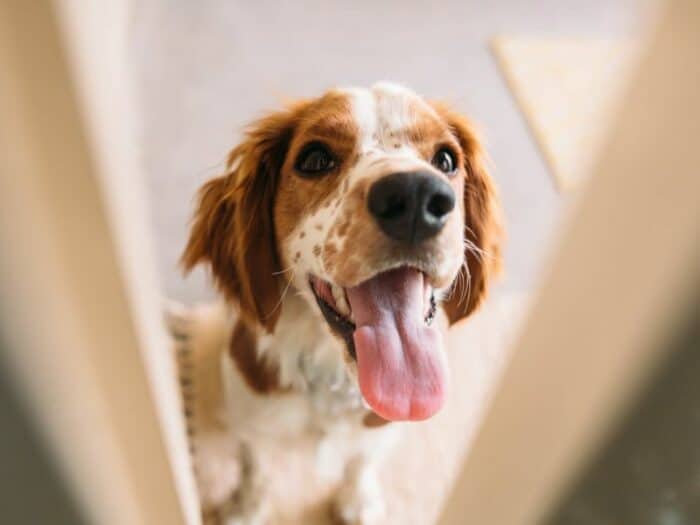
[131,0,652,303]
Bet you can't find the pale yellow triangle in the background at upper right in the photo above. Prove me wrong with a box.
[493,37,638,191]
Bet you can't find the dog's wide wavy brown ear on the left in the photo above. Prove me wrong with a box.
[182,102,305,332]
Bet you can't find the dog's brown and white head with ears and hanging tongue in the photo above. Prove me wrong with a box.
[183,84,500,419]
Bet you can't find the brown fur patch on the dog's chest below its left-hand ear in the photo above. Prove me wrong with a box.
[229,321,286,394]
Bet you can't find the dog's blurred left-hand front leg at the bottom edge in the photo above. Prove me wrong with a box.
[219,442,270,525]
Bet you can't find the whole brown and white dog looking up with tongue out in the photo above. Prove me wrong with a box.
[183,83,501,523]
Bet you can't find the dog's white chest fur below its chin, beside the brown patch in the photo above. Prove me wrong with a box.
[222,300,365,439]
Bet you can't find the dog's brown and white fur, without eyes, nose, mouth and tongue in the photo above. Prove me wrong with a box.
[183,83,501,523]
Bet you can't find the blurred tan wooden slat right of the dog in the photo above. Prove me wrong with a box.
[442,0,700,525]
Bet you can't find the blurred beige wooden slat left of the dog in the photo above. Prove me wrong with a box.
[0,0,199,525]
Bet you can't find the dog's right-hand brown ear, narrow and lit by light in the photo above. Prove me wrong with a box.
[433,103,503,324]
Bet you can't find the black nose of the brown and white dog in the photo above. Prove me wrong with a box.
[368,172,455,242]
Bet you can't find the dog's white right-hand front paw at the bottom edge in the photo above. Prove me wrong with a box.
[333,482,386,525]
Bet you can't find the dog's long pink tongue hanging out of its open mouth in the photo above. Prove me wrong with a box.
[347,268,447,420]
